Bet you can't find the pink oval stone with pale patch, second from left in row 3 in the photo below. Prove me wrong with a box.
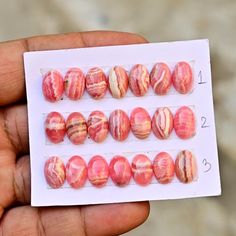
[66,156,87,188]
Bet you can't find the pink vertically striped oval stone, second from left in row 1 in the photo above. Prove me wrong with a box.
[64,68,85,100]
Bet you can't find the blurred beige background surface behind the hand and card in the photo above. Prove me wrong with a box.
[0,0,236,236]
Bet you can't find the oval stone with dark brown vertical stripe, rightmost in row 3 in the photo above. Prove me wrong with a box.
[175,150,197,183]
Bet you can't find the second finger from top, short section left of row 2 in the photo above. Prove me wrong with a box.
[0,105,29,155]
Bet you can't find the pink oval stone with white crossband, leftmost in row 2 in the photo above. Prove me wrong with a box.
[44,112,66,143]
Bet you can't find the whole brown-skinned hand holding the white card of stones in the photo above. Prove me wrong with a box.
[0,31,149,236]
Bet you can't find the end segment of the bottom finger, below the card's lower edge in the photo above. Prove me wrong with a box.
[83,202,150,236]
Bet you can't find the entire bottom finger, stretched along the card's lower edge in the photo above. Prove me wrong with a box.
[0,202,149,236]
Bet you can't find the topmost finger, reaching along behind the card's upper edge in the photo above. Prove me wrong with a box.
[0,31,147,105]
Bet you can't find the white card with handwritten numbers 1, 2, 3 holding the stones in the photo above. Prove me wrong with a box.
[24,40,221,206]
